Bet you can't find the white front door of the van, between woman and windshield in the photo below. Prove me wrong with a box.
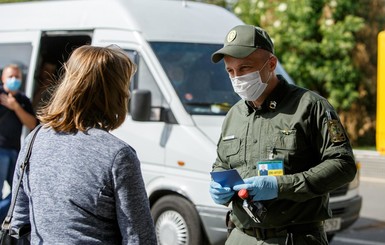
[92,30,167,184]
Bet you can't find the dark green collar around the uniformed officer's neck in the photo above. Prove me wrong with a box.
[244,75,288,116]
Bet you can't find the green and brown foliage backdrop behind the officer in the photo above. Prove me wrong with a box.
[202,0,385,145]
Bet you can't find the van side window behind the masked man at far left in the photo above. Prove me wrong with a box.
[0,43,32,92]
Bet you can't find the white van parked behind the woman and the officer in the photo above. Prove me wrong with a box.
[0,0,356,244]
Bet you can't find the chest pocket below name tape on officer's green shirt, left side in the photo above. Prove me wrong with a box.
[220,138,243,168]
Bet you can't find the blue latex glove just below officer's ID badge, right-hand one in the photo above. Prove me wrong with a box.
[233,176,278,201]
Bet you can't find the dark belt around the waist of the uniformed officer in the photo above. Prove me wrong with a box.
[240,222,323,240]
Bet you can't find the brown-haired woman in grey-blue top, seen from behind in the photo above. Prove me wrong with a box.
[11,45,157,245]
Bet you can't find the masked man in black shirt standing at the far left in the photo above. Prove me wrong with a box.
[0,64,38,222]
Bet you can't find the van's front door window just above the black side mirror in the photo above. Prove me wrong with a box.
[127,51,168,107]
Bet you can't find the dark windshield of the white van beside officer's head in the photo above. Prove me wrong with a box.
[151,42,240,115]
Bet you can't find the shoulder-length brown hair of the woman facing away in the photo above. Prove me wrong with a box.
[37,45,136,133]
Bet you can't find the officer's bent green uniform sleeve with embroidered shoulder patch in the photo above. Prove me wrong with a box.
[277,100,357,201]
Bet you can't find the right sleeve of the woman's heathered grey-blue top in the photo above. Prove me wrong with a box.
[112,147,157,245]
